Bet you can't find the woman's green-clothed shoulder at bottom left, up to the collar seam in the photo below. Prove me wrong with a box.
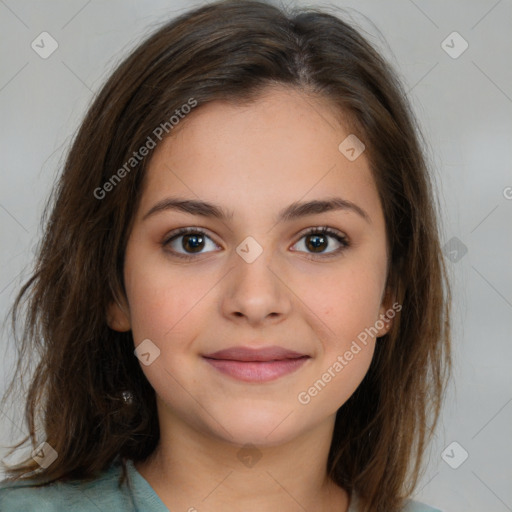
[0,464,133,512]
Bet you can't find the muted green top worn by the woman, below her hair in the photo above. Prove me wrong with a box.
[0,460,440,512]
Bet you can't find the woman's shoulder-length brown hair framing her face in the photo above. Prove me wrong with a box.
[0,0,451,512]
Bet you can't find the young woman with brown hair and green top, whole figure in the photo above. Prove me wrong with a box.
[0,1,450,512]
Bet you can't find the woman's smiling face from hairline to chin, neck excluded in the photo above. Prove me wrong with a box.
[109,88,389,445]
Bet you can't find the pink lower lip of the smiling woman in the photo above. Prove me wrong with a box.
[205,357,309,382]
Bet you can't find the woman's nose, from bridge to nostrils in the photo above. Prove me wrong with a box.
[221,250,291,327]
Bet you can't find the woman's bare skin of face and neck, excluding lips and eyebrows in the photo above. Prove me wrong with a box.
[108,87,392,512]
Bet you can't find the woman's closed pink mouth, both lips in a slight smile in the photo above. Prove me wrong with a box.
[203,347,310,382]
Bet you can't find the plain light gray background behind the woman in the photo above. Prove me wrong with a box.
[0,0,512,512]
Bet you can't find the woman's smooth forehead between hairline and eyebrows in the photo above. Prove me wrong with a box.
[141,87,379,224]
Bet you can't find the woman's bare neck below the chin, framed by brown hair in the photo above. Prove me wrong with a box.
[135,408,349,512]
